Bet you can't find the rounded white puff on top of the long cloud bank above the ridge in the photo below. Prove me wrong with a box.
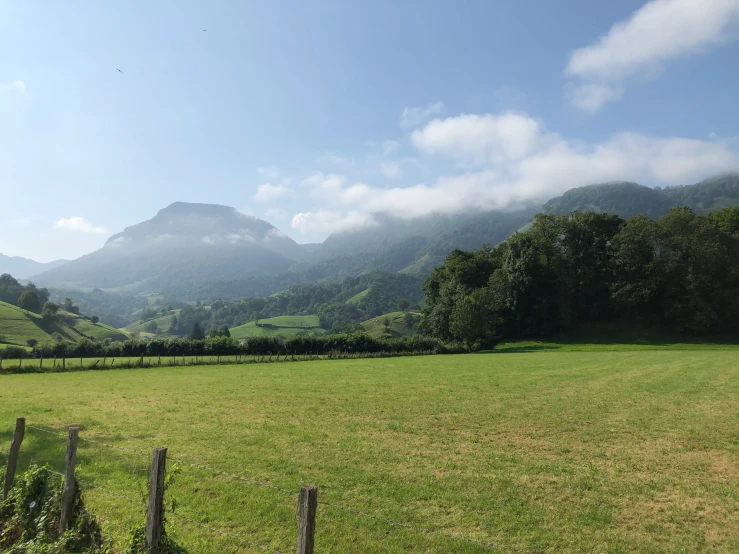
[411,112,543,164]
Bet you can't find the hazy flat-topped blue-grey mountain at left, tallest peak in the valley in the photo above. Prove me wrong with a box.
[33,202,305,292]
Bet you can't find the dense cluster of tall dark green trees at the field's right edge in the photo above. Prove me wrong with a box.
[422,207,739,346]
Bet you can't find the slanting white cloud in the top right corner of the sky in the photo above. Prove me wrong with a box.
[565,0,739,113]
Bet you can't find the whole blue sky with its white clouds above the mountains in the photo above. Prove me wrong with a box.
[0,0,739,261]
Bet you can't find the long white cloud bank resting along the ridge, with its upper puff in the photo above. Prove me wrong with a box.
[292,113,739,236]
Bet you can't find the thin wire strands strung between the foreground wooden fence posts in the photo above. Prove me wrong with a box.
[0,425,537,554]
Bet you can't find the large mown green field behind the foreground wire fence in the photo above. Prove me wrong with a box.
[0,348,739,553]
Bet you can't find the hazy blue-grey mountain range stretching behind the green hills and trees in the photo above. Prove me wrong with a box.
[21,174,739,300]
